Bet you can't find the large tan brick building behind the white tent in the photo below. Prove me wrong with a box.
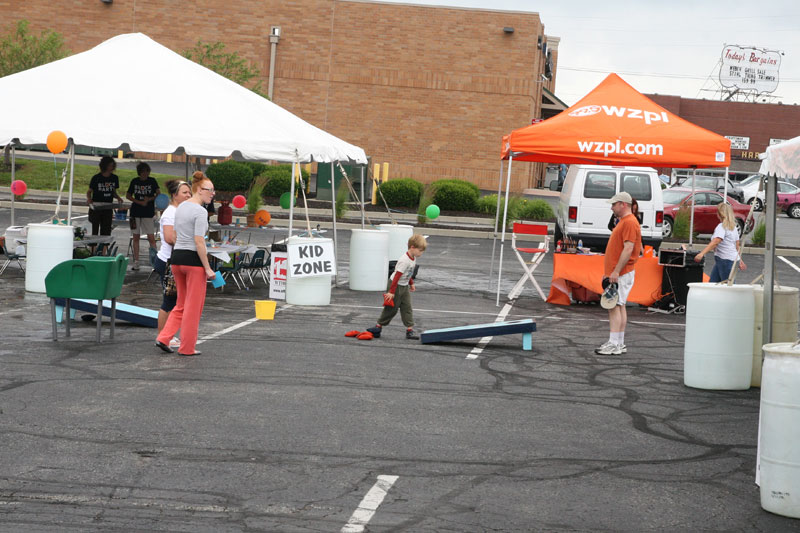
[0,0,565,191]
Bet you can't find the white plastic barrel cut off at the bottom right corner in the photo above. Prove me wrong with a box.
[758,343,800,518]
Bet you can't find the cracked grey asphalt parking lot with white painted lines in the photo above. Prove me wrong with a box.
[0,209,800,532]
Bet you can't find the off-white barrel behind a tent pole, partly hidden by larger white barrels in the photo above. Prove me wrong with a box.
[750,285,800,387]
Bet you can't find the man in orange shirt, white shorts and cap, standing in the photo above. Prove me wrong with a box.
[595,192,642,355]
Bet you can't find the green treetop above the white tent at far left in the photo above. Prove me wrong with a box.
[0,20,70,78]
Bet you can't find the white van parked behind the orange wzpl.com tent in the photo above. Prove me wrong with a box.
[555,165,664,251]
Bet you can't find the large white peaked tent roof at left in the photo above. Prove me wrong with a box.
[0,33,367,163]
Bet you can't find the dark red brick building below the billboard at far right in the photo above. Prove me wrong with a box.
[646,94,800,178]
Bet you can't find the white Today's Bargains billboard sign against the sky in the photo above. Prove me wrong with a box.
[719,46,781,94]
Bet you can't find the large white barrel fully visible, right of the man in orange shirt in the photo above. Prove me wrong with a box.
[683,283,754,390]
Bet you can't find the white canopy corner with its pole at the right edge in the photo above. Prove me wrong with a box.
[758,137,800,344]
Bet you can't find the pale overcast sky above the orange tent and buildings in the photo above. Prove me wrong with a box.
[379,0,800,105]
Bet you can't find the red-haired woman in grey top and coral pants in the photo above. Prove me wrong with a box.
[156,171,215,355]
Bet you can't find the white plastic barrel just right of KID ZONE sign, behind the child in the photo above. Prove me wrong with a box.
[350,229,389,291]
